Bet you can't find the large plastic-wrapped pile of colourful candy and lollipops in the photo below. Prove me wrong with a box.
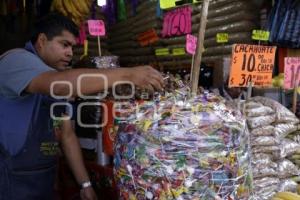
[114,87,252,200]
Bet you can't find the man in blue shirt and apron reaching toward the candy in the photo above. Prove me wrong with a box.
[0,14,163,200]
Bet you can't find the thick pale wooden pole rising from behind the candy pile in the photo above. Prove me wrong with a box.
[191,0,209,95]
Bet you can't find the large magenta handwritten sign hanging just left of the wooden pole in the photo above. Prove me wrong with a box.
[162,7,192,37]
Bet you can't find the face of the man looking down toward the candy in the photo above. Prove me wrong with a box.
[38,31,76,71]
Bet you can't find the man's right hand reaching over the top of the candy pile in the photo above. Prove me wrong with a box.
[129,66,164,91]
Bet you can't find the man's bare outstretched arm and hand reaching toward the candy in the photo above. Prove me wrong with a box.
[26,66,163,96]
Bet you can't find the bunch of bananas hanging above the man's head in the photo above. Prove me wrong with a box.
[51,0,92,26]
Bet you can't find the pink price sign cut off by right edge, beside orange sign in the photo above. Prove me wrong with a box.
[284,57,300,89]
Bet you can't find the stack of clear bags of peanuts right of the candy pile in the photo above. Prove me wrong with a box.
[245,97,300,200]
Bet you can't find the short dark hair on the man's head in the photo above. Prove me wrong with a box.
[31,12,79,44]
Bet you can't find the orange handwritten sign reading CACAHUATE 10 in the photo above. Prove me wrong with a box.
[229,44,276,87]
